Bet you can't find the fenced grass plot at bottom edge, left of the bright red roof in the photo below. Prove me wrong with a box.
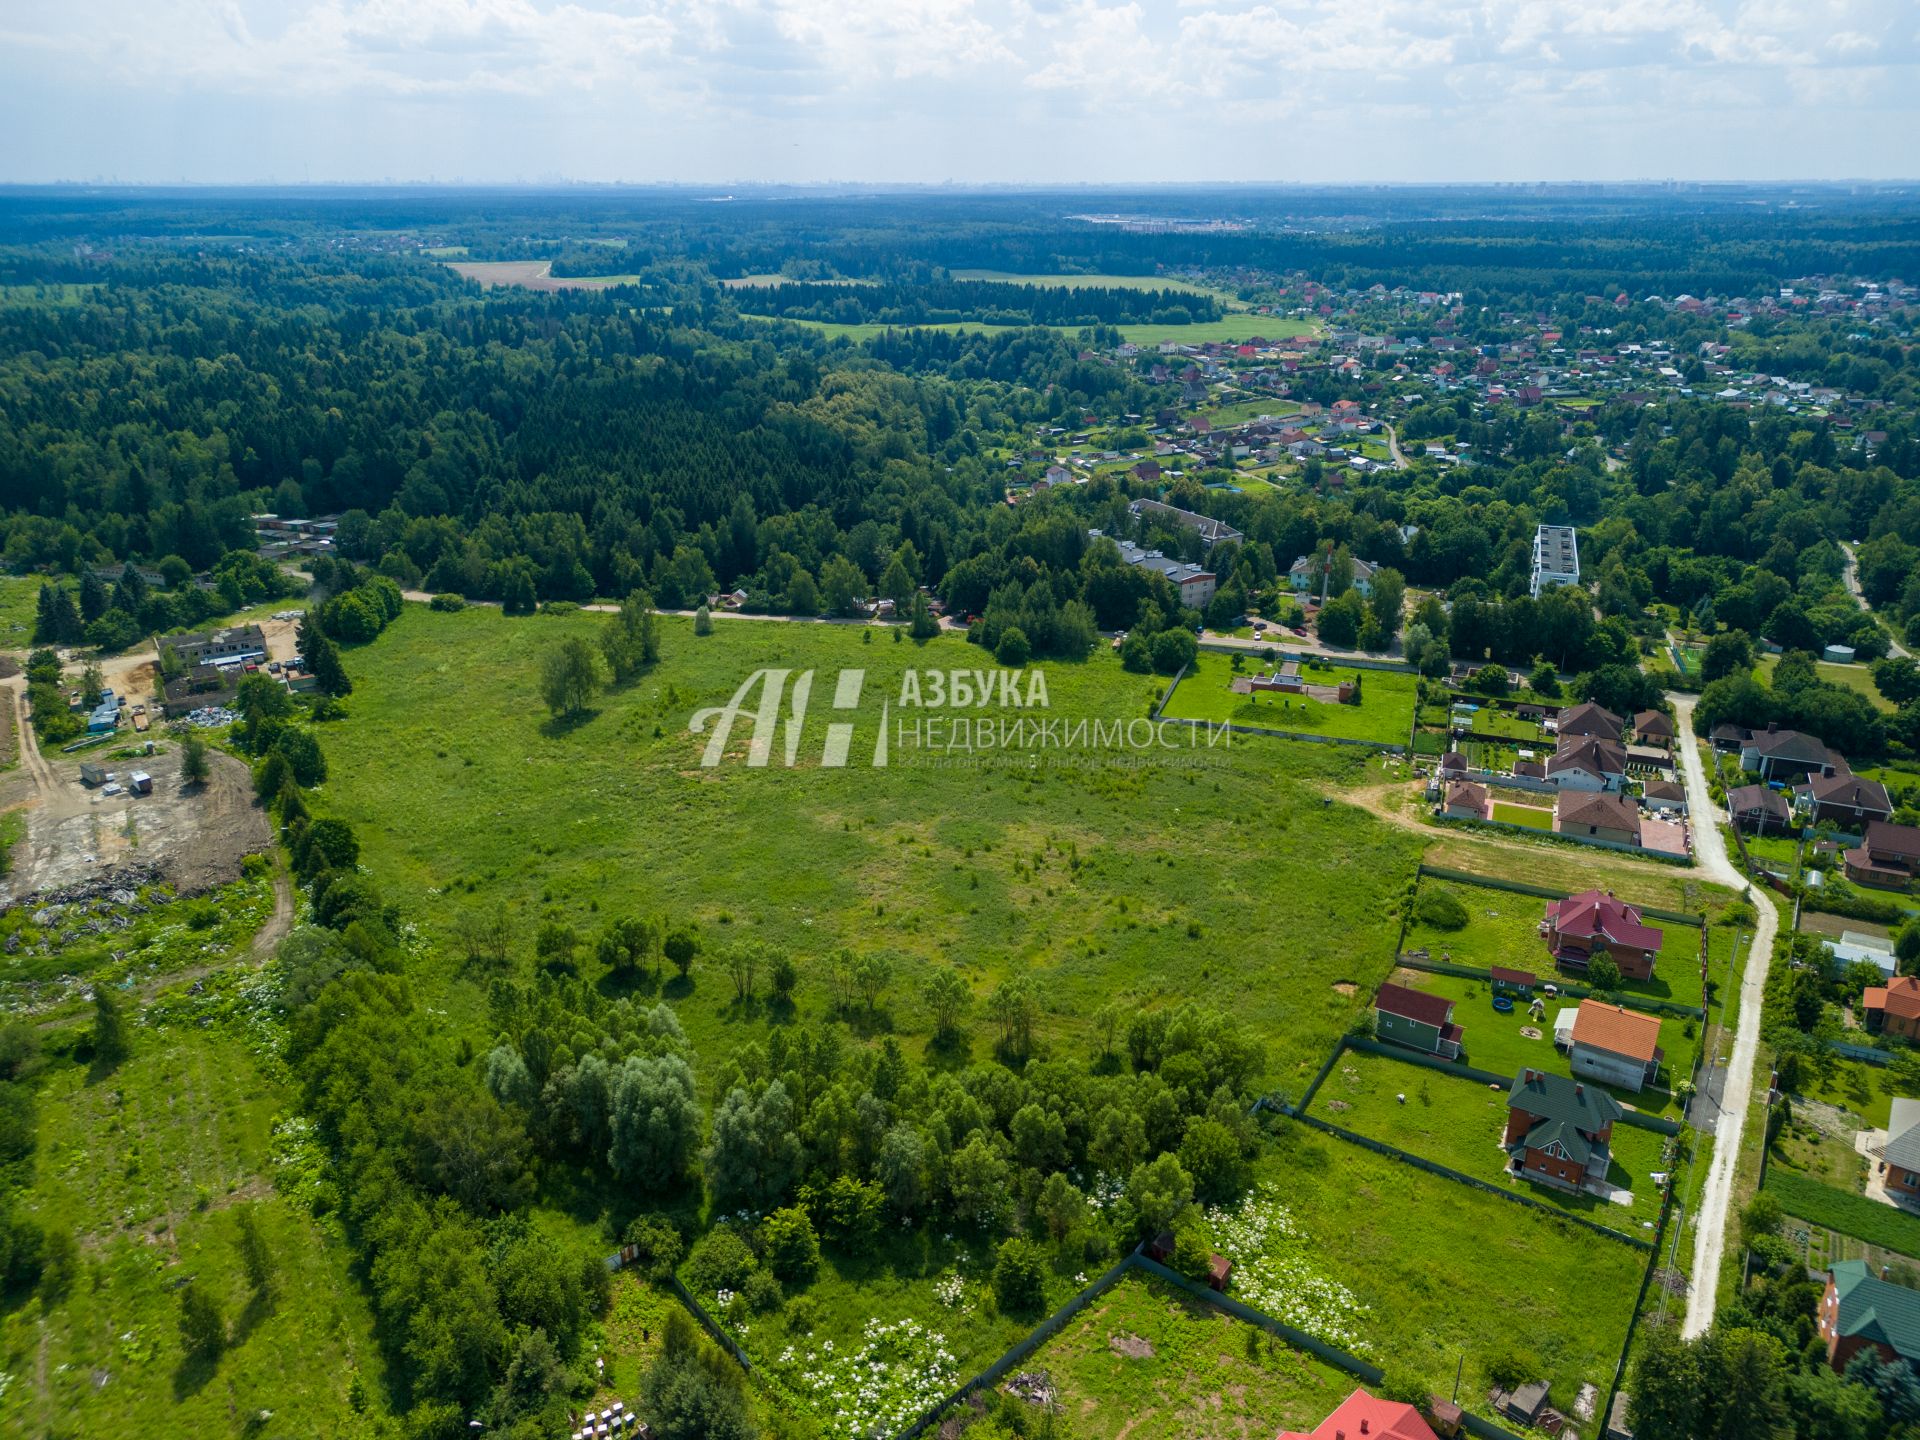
[1021,1273,1359,1440]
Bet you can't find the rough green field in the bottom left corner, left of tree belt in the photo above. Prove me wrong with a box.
[0,991,382,1440]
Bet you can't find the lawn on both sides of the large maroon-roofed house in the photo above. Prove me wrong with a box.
[1400,879,1734,1006]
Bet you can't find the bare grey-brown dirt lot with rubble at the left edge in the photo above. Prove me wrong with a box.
[0,741,273,906]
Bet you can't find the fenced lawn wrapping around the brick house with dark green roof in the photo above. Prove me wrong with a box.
[1313,1050,1665,1235]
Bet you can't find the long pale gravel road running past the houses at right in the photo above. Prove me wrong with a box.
[1667,695,1780,1338]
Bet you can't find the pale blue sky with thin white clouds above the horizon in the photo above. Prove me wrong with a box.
[0,0,1920,184]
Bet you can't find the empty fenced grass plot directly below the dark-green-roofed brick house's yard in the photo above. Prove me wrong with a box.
[1260,1125,1645,1407]
